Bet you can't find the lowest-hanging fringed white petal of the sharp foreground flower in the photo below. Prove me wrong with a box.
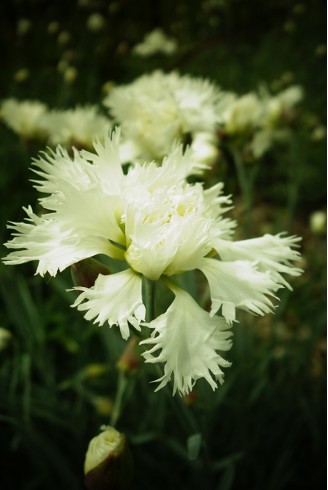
[141,287,232,395]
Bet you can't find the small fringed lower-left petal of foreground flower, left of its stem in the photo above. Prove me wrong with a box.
[73,269,146,339]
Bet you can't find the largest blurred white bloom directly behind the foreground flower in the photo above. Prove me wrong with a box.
[104,71,223,162]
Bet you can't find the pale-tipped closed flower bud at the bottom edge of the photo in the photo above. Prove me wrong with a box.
[84,426,133,490]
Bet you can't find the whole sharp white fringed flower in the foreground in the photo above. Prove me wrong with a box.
[4,129,301,394]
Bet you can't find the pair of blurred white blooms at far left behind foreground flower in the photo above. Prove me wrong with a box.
[0,99,112,148]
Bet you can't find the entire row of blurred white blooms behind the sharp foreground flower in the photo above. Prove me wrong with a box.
[0,74,303,166]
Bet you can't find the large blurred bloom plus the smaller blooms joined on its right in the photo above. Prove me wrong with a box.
[103,70,303,164]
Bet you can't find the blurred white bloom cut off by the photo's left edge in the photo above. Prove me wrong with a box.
[0,98,47,138]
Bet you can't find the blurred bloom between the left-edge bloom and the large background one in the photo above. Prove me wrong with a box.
[43,105,111,148]
